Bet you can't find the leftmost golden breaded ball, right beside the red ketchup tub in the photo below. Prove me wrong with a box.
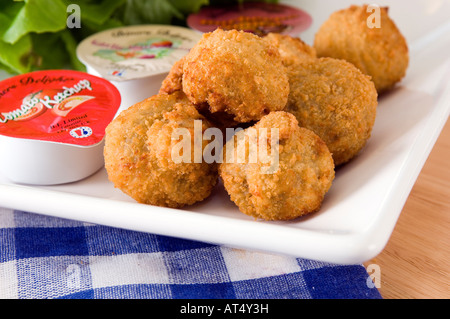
[104,92,218,208]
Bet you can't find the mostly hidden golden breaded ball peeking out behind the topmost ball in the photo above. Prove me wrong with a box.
[263,33,317,67]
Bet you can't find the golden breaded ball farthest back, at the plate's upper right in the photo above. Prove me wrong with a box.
[314,5,409,93]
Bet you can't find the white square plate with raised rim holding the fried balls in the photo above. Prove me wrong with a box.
[0,0,450,264]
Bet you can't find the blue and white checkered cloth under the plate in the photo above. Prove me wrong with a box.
[0,208,381,299]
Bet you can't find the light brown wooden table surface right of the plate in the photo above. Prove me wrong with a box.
[365,120,450,299]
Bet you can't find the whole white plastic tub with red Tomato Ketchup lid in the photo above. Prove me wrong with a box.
[0,70,120,185]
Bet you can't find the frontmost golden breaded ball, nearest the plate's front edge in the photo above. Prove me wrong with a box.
[219,111,334,220]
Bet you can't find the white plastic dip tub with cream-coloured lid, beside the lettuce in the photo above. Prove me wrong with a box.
[77,25,201,113]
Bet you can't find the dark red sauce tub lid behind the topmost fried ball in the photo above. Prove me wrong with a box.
[187,2,312,36]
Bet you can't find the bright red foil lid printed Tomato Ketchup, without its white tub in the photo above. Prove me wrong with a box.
[0,70,120,146]
